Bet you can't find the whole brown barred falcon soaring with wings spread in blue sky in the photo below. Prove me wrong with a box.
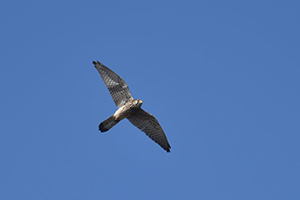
[93,61,171,152]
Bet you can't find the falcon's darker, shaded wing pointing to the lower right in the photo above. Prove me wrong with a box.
[127,109,171,152]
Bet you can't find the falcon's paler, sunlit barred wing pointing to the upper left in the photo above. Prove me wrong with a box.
[93,61,132,107]
